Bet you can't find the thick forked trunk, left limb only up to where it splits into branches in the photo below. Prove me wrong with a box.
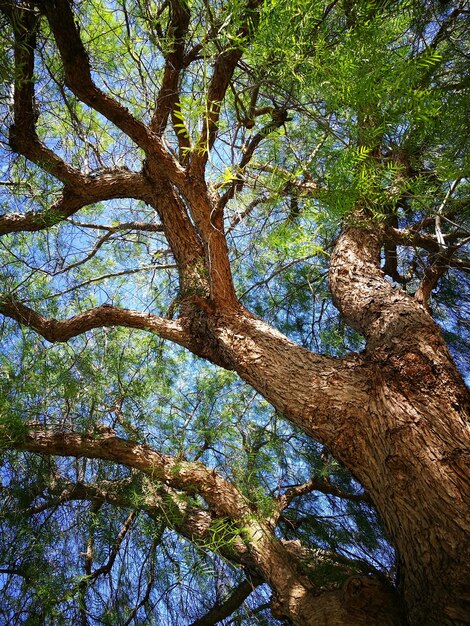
[185,226,470,626]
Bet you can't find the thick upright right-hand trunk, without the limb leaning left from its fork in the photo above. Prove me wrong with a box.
[331,227,470,626]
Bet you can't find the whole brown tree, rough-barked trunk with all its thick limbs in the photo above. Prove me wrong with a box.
[0,0,470,626]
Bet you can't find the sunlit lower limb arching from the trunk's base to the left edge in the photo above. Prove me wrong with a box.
[4,425,399,626]
